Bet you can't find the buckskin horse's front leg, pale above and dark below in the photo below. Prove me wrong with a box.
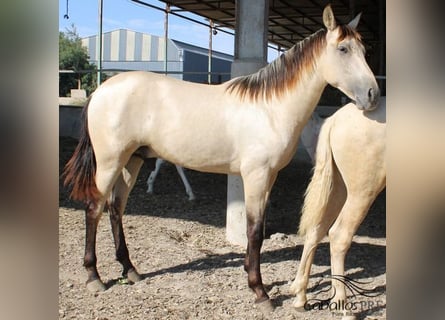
[243,169,277,307]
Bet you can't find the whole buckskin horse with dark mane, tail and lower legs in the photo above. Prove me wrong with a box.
[65,6,379,306]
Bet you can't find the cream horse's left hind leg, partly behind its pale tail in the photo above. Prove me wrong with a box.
[290,170,346,309]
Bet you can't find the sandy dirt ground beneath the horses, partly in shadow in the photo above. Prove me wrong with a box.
[59,138,386,320]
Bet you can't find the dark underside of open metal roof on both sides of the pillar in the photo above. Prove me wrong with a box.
[155,0,386,49]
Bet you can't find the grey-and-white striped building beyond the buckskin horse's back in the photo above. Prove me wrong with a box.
[82,29,233,84]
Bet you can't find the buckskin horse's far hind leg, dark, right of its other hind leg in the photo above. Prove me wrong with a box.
[109,156,144,282]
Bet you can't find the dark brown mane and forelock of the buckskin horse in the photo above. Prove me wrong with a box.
[226,25,360,101]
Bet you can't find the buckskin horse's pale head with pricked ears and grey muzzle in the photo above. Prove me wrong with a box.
[321,5,380,110]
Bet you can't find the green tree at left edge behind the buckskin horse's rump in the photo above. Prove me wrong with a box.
[59,25,97,97]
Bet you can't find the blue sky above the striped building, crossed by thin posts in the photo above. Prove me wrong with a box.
[59,0,277,61]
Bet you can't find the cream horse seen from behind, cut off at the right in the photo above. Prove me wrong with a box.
[291,97,386,318]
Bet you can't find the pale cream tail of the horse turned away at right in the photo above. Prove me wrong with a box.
[298,117,334,236]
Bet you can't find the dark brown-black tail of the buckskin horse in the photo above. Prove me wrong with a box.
[63,96,100,202]
